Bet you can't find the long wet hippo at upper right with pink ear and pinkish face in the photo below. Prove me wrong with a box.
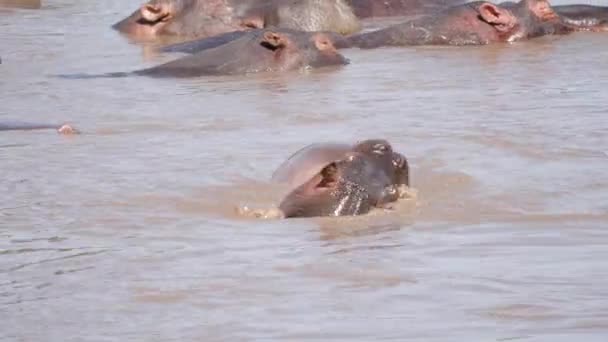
[337,0,572,48]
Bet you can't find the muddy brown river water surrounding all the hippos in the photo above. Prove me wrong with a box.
[0,0,608,341]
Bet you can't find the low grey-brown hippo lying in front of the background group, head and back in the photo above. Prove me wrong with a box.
[135,30,348,77]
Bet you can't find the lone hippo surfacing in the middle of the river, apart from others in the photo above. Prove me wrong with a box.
[272,140,409,217]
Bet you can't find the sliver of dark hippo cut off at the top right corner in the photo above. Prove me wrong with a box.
[553,5,608,32]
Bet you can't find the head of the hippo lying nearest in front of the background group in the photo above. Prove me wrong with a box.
[259,29,348,70]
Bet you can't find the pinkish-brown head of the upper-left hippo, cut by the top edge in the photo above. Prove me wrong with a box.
[113,0,247,40]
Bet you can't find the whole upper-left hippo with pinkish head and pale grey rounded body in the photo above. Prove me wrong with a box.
[112,0,360,41]
